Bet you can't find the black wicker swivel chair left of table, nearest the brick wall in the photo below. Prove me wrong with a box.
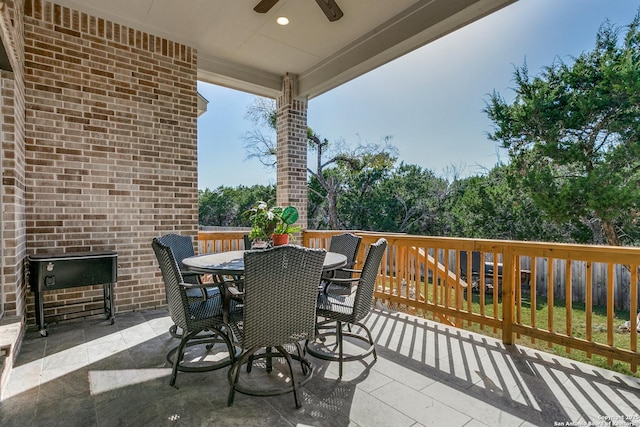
[151,238,236,386]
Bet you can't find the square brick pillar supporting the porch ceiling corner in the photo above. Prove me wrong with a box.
[276,74,308,228]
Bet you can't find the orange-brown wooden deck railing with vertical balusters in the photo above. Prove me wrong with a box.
[198,230,640,372]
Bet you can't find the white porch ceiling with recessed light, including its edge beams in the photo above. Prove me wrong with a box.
[54,0,516,98]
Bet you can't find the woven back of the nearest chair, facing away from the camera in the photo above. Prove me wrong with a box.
[241,245,326,348]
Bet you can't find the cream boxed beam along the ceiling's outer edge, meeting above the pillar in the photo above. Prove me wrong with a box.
[198,0,517,98]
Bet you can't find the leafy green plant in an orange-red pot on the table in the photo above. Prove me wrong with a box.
[247,201,301,246]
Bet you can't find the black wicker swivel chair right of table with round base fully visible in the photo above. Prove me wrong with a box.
[306,239,387,378]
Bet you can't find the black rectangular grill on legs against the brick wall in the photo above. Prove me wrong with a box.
[28,252,118,336]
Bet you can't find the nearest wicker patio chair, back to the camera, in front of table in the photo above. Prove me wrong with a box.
[227,245,326,408]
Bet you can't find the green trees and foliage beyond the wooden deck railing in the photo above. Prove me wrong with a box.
[199,16,640,245]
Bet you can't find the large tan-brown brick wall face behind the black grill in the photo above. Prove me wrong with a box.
[25,0,198,321]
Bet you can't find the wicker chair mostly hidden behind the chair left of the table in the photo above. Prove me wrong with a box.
[157,233,220,338]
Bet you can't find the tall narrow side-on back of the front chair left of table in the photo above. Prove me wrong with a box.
[151,236,188,329]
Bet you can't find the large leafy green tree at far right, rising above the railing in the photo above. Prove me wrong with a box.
[485,15,640,245]
